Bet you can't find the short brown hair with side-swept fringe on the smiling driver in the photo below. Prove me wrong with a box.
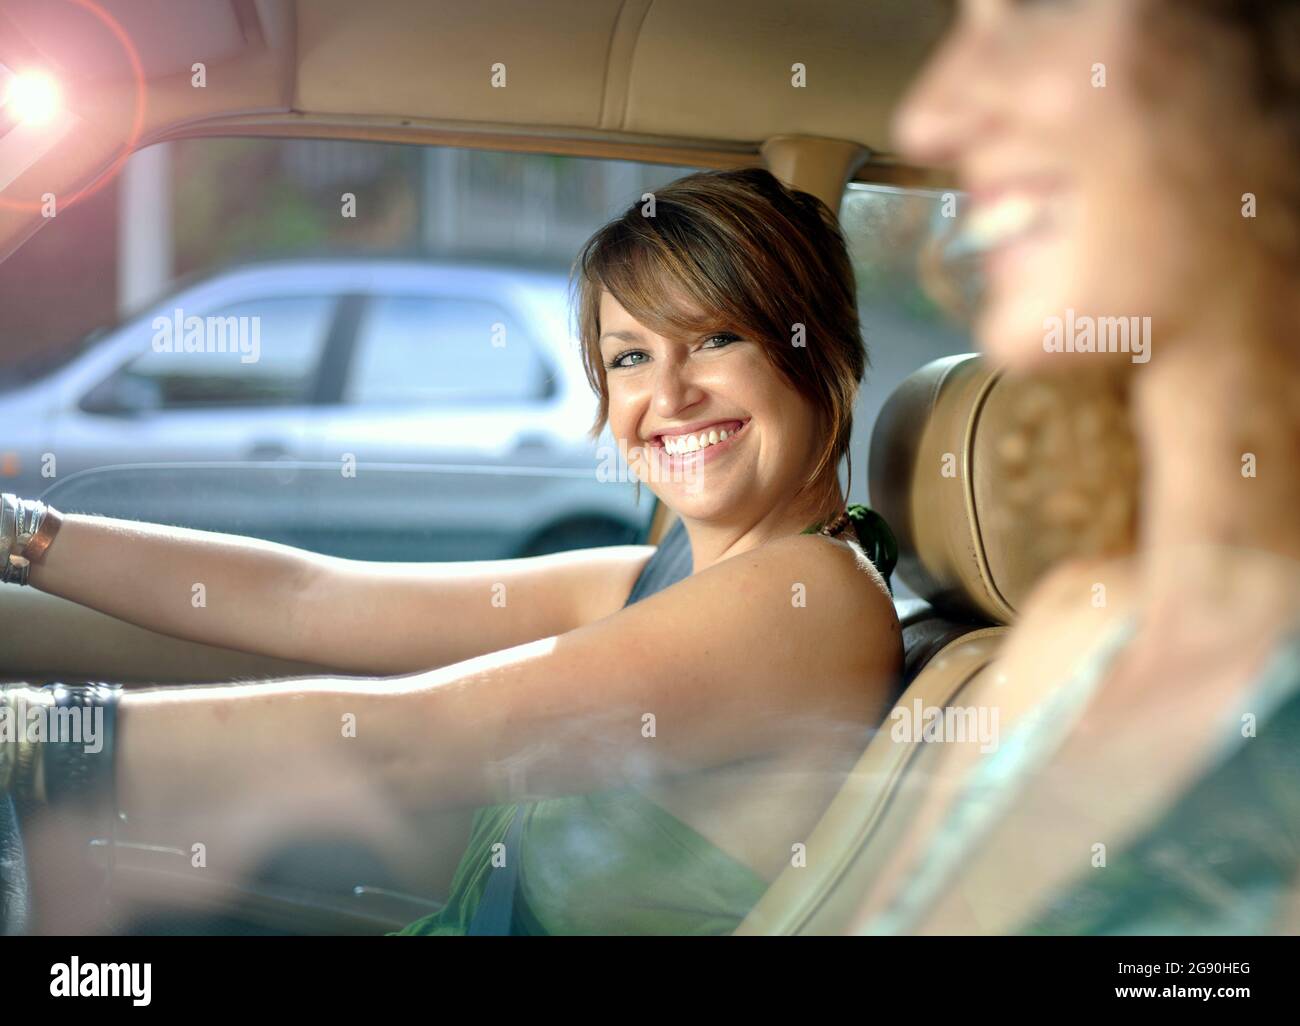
[573,168,868,512]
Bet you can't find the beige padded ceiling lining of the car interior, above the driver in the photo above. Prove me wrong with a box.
[0,0,945,259]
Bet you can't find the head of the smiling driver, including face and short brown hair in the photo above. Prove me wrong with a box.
[576,168,867,567]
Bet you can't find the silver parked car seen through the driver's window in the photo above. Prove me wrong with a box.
[0,260,651,559]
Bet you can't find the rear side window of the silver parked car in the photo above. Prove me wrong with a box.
[345,295,553,406]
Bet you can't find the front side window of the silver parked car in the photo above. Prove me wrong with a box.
[121,296,334,410]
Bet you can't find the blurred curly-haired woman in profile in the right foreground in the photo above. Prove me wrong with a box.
[858,0,1300,934]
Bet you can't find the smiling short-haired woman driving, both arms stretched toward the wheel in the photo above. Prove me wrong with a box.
[0,169,902,934]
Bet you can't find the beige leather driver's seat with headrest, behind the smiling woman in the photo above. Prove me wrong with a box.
[737,355,1081,934]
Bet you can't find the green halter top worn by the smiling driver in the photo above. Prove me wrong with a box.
[399,505,898,936]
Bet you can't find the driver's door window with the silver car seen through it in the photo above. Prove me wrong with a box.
[0,137,694,560]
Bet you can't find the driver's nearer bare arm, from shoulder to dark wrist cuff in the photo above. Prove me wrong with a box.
[117,537,901,858]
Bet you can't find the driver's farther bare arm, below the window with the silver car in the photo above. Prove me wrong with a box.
[31,516,653,675]
